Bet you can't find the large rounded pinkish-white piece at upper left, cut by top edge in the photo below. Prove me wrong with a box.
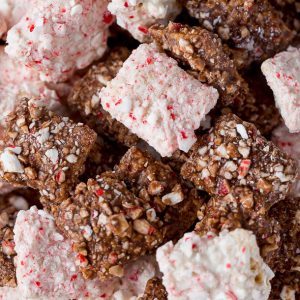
[6,0,113,82]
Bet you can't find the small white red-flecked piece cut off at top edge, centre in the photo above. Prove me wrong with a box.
[108,0,181,42]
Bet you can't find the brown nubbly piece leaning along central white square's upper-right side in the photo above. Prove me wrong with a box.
[150,22,249,105]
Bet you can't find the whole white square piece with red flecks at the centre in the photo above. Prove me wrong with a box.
[99,44,218,156]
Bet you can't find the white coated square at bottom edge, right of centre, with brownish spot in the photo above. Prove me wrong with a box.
[156,229,274,300]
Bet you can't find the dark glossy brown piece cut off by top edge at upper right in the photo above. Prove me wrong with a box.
[186,0,294,62]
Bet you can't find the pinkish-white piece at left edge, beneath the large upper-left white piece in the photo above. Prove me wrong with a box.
[0,47,62,124]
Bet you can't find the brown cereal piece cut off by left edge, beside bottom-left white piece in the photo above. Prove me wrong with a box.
[0,193,28,287]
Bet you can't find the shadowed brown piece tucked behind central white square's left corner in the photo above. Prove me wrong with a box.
[67,47,138,146]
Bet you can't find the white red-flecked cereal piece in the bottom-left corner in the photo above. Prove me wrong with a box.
[14,207,118,300]
